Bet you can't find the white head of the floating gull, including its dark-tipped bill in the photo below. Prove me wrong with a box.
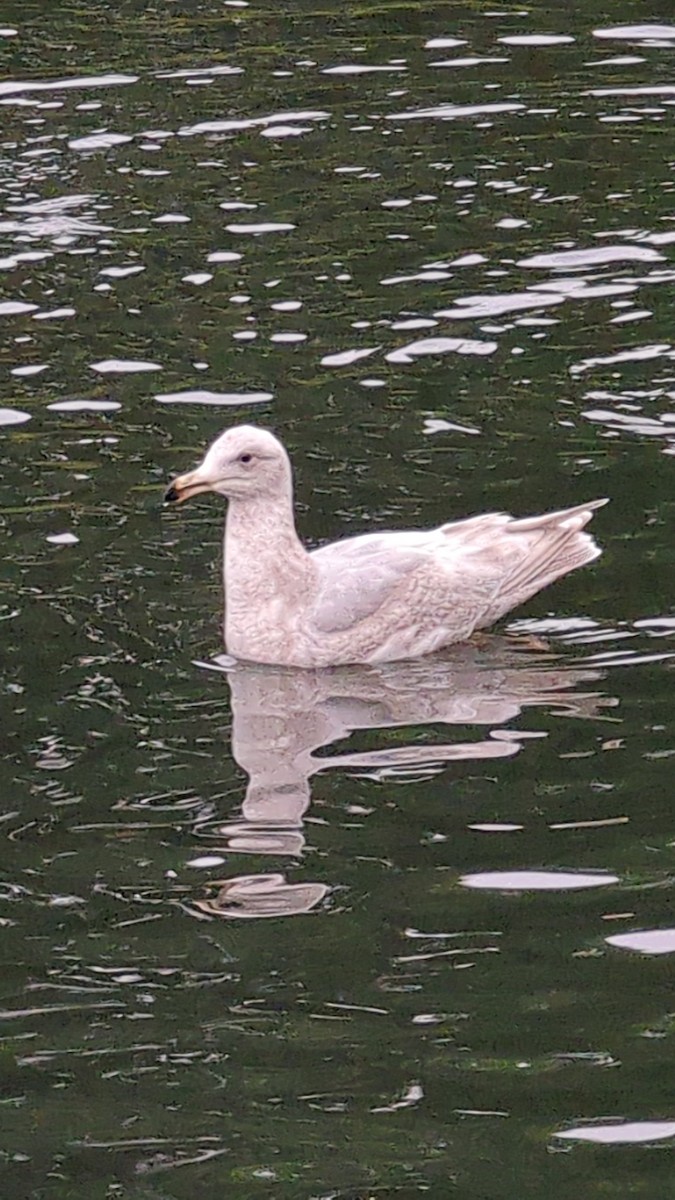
[165,425,291,503]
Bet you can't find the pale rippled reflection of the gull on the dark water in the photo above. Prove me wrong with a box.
[187,637,616,918]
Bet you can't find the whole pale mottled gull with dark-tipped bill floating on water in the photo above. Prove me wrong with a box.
[167,425,607,667]
